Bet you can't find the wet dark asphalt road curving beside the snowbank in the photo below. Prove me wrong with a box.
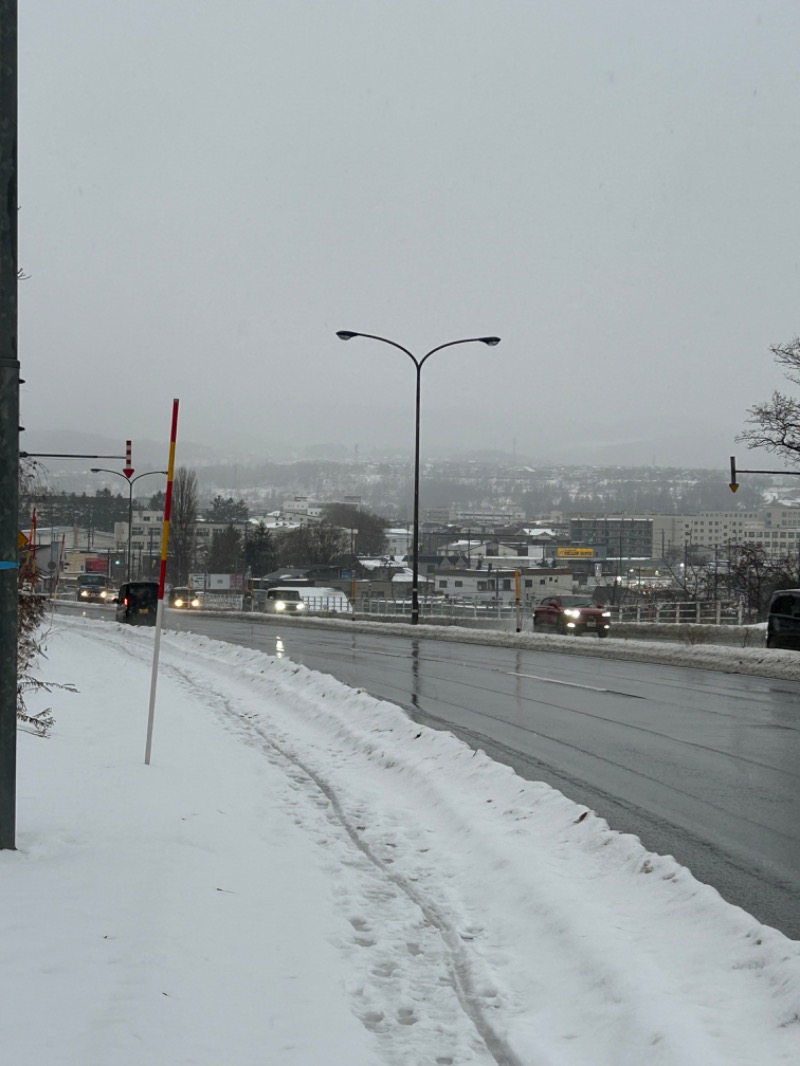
[67,611,800,939]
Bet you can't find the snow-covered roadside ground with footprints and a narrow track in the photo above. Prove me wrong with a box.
[6,616,800,1066]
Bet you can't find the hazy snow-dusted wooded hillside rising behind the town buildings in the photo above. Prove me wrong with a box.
[21,432,785,522]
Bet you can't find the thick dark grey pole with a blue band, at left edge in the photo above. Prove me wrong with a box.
[0,0,19,849]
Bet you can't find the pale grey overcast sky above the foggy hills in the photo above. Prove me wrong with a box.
[19,0,800,466]
